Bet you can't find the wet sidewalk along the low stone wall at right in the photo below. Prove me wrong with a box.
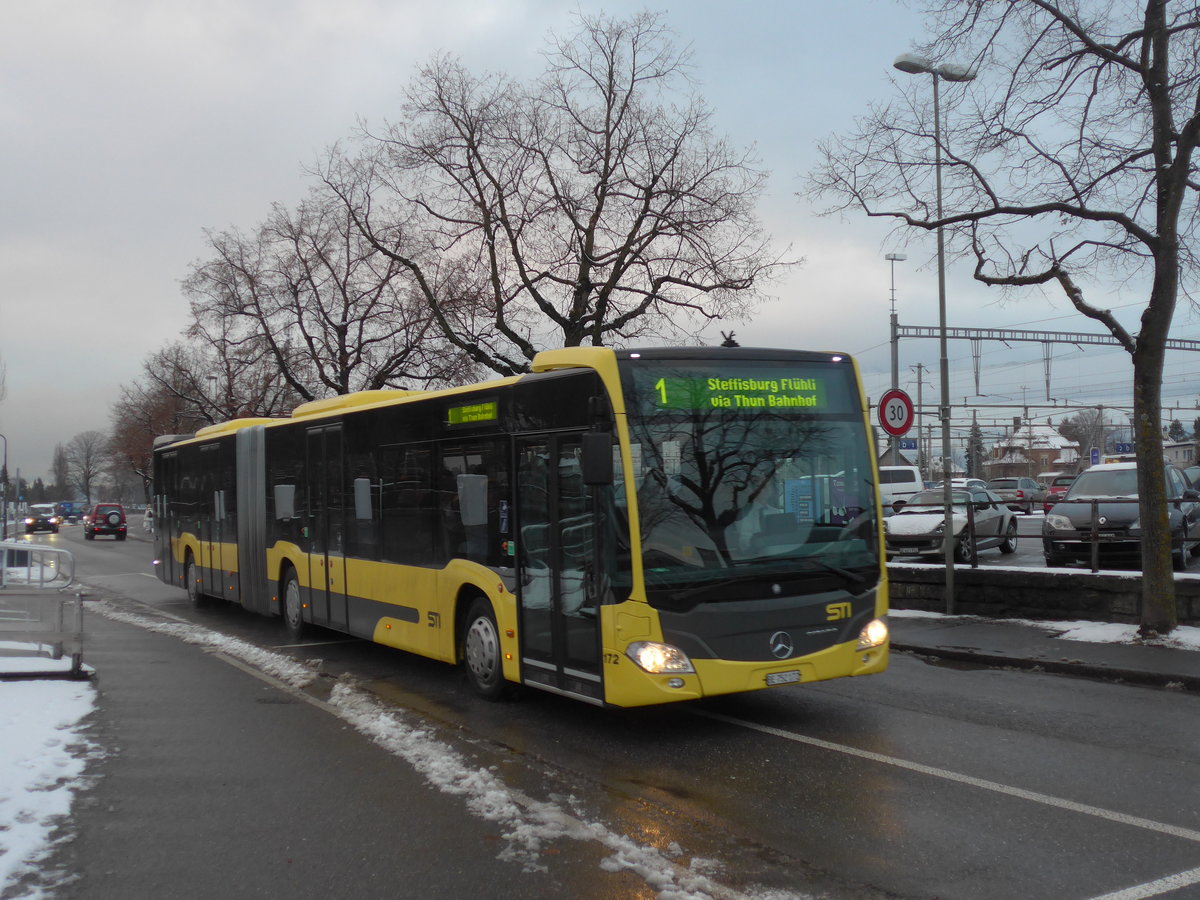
[888,611,1200,691]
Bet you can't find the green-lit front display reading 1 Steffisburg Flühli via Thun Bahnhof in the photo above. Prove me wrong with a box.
[654,376,826,410]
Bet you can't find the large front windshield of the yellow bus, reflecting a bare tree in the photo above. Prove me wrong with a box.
[617,358,880,601]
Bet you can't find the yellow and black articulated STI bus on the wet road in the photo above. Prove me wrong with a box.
[154,347,888,707]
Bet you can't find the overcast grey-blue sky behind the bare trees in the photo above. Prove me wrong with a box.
[0,0,1200,494]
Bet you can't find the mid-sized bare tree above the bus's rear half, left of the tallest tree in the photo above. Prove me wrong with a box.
[185,193,466,400]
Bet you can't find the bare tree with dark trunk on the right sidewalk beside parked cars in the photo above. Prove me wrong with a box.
[811,0,1200,634]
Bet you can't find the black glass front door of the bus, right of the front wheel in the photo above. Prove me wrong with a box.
[517,434,604,701]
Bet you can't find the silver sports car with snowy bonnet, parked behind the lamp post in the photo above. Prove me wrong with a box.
[883,487,1016,563]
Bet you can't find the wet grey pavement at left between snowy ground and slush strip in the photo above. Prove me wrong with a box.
[19,602,628,900]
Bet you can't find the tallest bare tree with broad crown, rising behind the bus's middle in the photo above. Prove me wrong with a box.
[322,13,784,374]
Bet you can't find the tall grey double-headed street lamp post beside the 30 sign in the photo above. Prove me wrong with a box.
[892,53,976,613]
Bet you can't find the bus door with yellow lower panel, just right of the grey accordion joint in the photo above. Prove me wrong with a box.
[306,425,349,631]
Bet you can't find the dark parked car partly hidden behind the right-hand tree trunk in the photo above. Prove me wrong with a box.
[1042,462,1200,570]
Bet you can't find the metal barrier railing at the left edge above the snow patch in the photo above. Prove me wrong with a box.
[0,541,84,678]
